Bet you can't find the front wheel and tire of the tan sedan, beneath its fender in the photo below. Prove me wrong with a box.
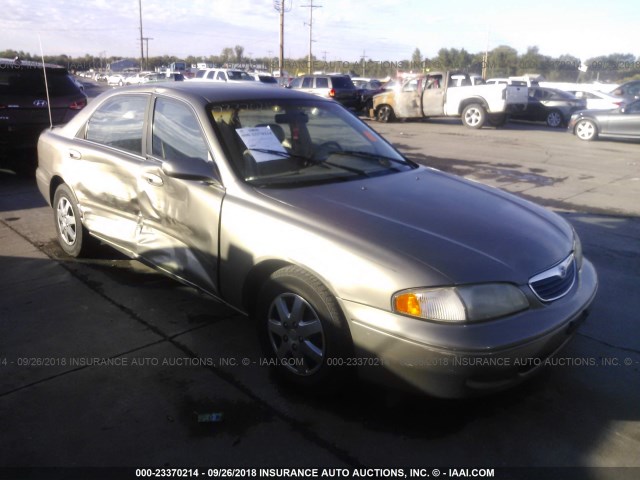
[255,266,353,393]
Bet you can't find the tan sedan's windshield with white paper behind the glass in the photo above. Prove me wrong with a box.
[209,100,416,188]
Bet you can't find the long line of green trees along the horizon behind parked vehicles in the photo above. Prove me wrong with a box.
[0,45,640,83]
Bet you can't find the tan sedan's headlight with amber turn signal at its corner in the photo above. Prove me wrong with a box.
[391,283,529,322]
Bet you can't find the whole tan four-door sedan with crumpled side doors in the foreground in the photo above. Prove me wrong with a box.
[37,82,597,397]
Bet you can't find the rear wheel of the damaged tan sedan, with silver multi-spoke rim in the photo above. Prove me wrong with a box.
[53,184,96,257]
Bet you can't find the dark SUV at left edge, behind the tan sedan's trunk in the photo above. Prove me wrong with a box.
[0,58,87,174]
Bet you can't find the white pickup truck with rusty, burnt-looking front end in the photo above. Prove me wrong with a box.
[369,72,528,128]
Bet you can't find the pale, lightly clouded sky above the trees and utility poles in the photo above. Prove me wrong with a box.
[0,0,640,68]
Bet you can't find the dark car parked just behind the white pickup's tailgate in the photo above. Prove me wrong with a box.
[511,87,587,128]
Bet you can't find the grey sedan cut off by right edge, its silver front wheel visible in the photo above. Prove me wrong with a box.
[568,100,640,141]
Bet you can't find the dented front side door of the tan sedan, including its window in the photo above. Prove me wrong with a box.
[138,97,225,295]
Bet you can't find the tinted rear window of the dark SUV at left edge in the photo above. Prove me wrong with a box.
[0,68,80,96]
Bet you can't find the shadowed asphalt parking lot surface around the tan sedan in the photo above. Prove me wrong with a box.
[0,104,640,479]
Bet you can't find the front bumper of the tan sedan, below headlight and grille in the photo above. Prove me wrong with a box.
[341,259,598,398]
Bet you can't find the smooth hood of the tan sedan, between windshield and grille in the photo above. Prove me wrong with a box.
[261,168,573,284]
